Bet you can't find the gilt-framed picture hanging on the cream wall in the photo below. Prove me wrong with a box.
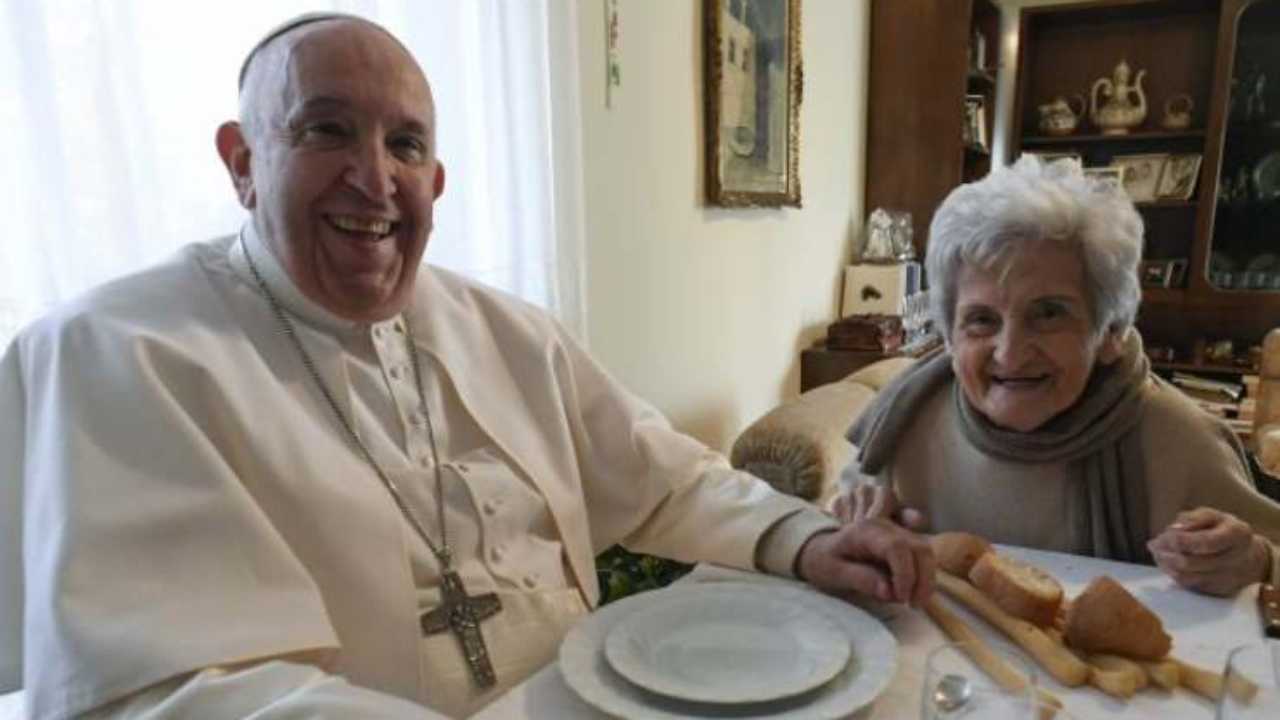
[703,0,803,208]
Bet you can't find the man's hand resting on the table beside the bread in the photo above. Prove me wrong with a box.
[796,518,934,606]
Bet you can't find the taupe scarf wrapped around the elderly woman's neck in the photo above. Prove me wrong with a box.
[846,329,1164,565]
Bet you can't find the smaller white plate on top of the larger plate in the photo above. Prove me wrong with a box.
[604,585,850,703]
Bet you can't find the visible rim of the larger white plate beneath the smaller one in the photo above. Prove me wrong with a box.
[559,583,897,720]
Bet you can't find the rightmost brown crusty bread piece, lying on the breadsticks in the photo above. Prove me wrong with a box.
[1066,575,1174,660]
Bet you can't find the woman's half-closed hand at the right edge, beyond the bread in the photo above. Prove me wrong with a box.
[1147,507,1271,596]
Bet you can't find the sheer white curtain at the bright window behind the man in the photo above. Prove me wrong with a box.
[0,0,585,348]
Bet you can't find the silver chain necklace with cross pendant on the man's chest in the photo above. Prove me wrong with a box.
[241,240,502,688]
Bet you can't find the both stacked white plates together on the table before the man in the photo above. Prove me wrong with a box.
[559,583,897,720]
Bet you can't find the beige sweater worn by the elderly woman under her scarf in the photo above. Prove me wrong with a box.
[842,371,1280,580]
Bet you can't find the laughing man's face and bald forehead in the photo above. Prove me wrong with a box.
[241,20,444,322]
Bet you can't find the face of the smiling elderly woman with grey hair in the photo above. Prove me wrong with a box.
[951,243,1120,432]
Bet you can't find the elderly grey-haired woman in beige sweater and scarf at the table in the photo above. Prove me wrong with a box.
[836,158,1280,594]
